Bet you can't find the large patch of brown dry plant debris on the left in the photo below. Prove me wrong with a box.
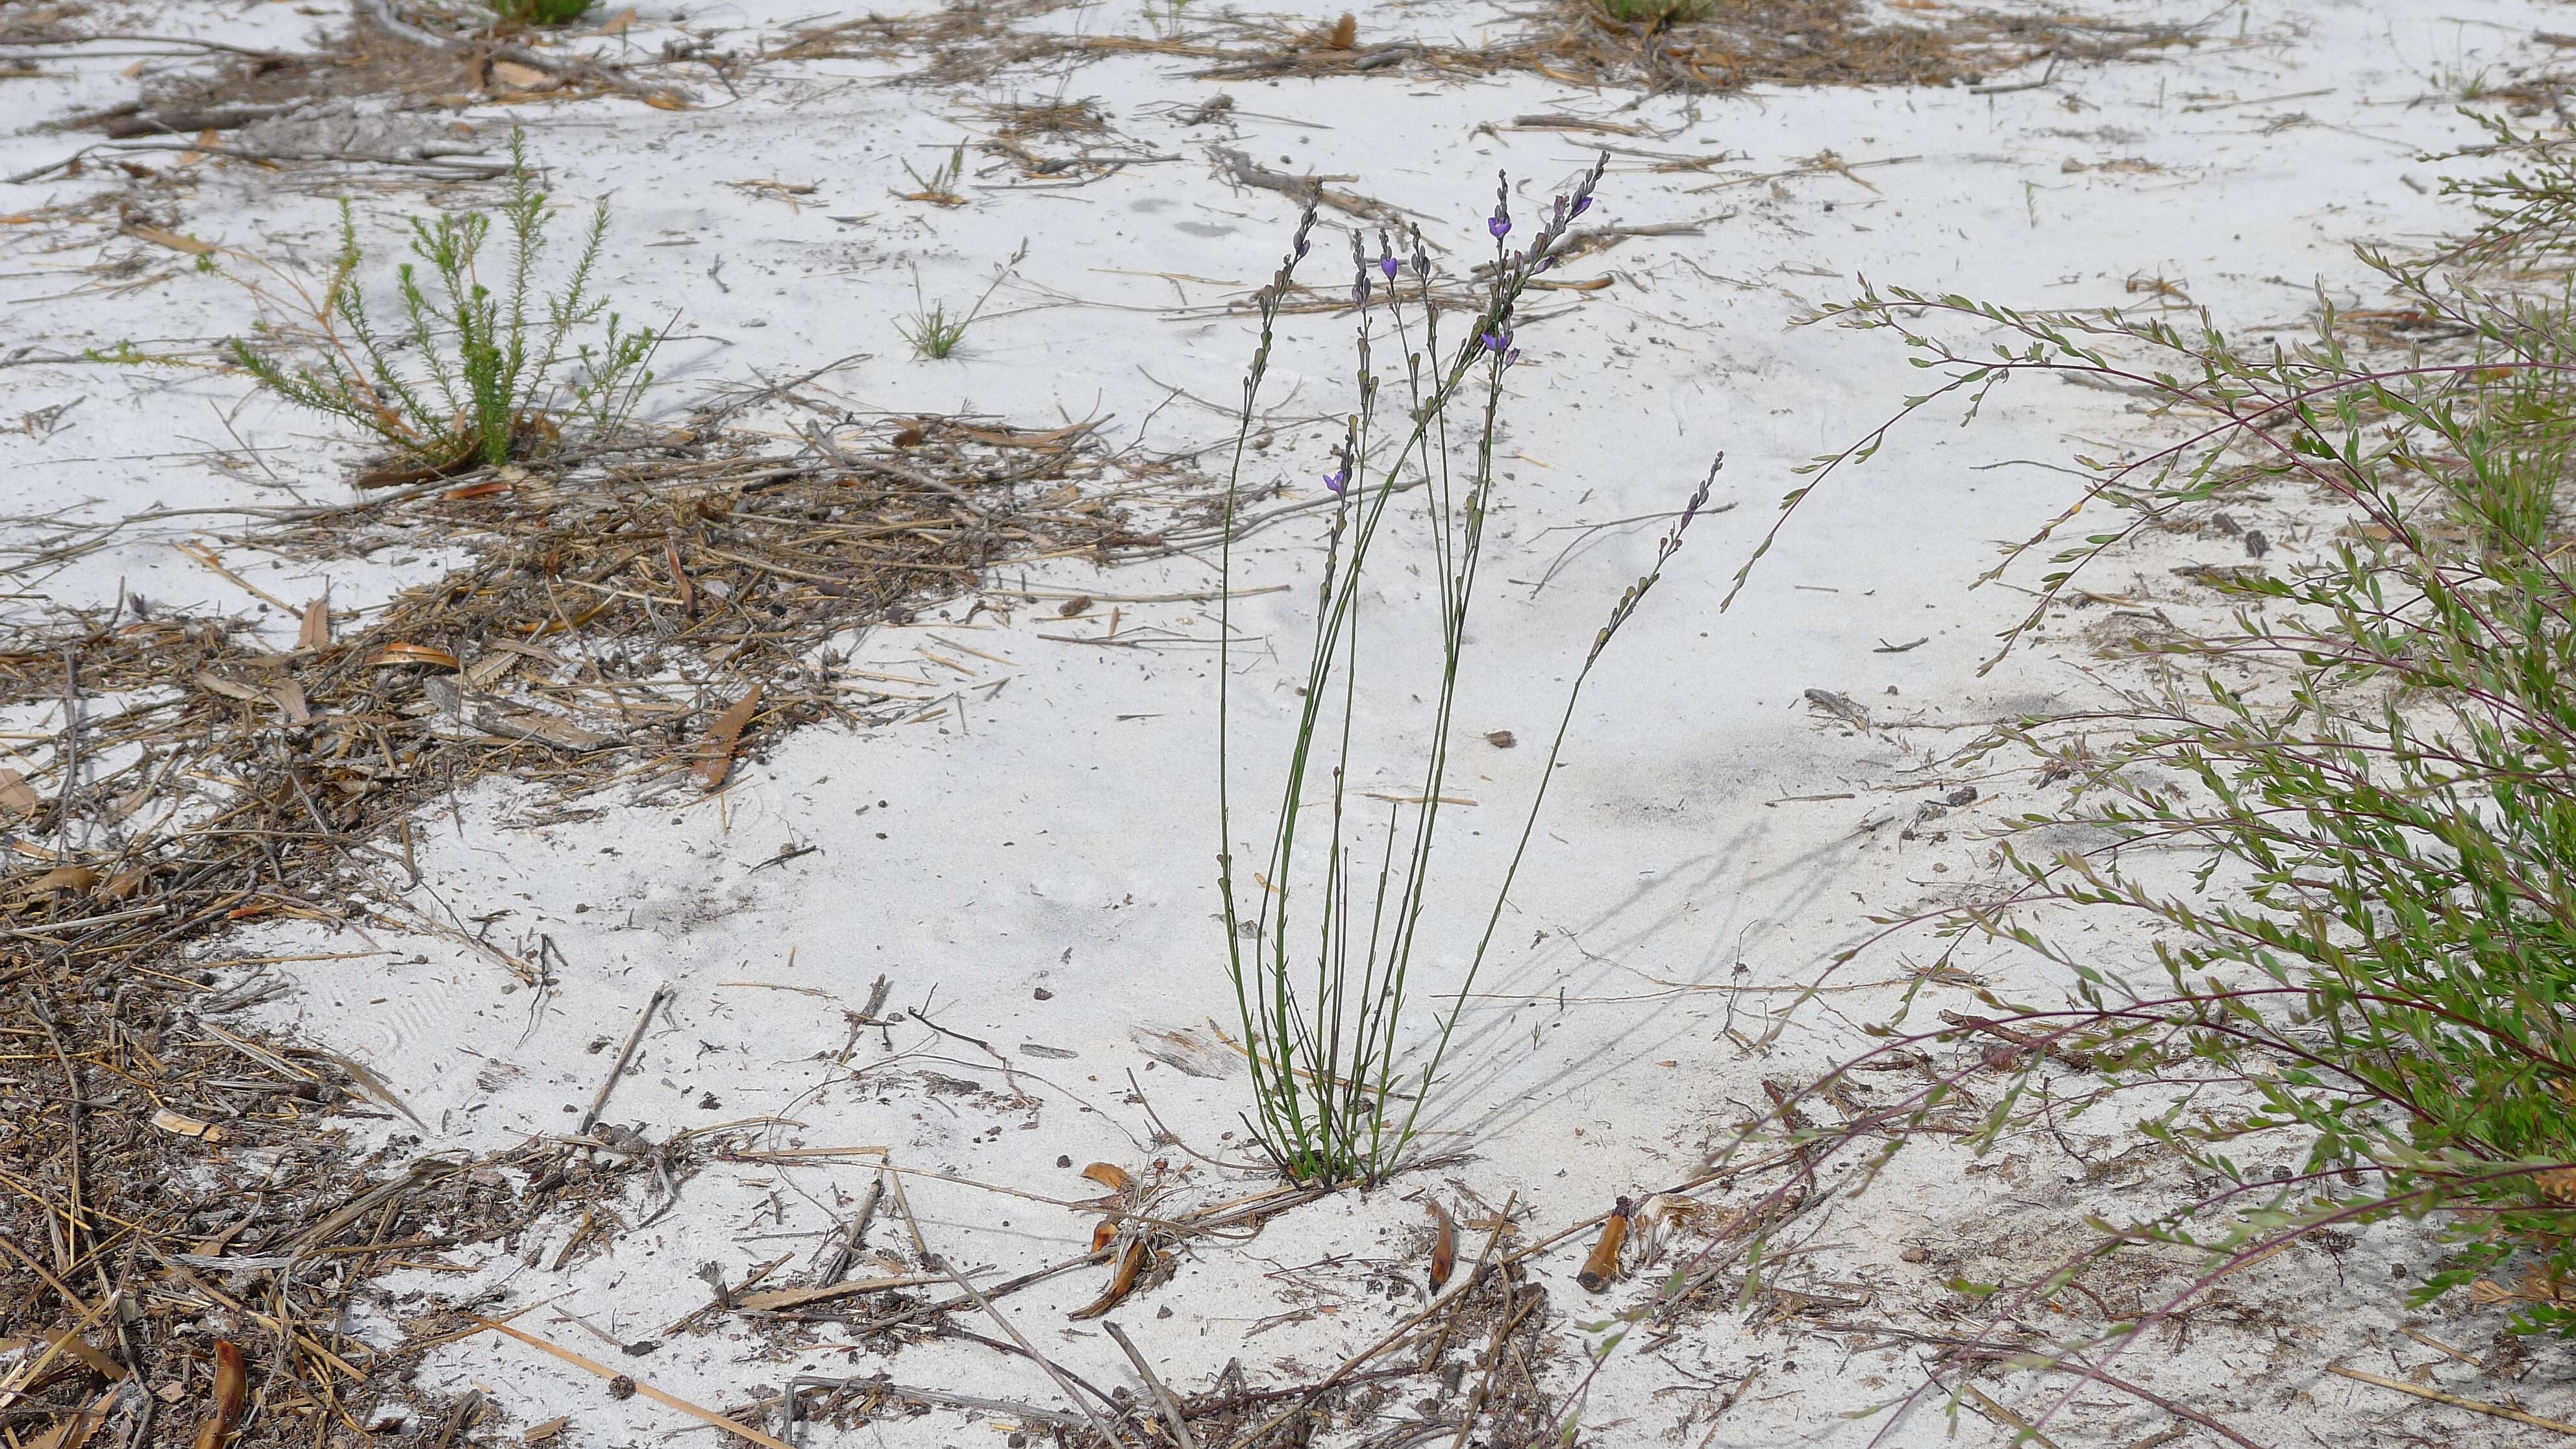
[0,415,1187,1449]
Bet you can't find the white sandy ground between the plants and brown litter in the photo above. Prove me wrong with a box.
[0,0,2566,1446]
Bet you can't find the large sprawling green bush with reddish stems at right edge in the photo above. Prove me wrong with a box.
[1669,115,2576,1433]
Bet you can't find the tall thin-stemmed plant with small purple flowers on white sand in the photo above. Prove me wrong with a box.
[1219,165,1716,1183]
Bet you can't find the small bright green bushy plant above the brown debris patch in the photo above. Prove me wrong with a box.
[229,132,662,464]
